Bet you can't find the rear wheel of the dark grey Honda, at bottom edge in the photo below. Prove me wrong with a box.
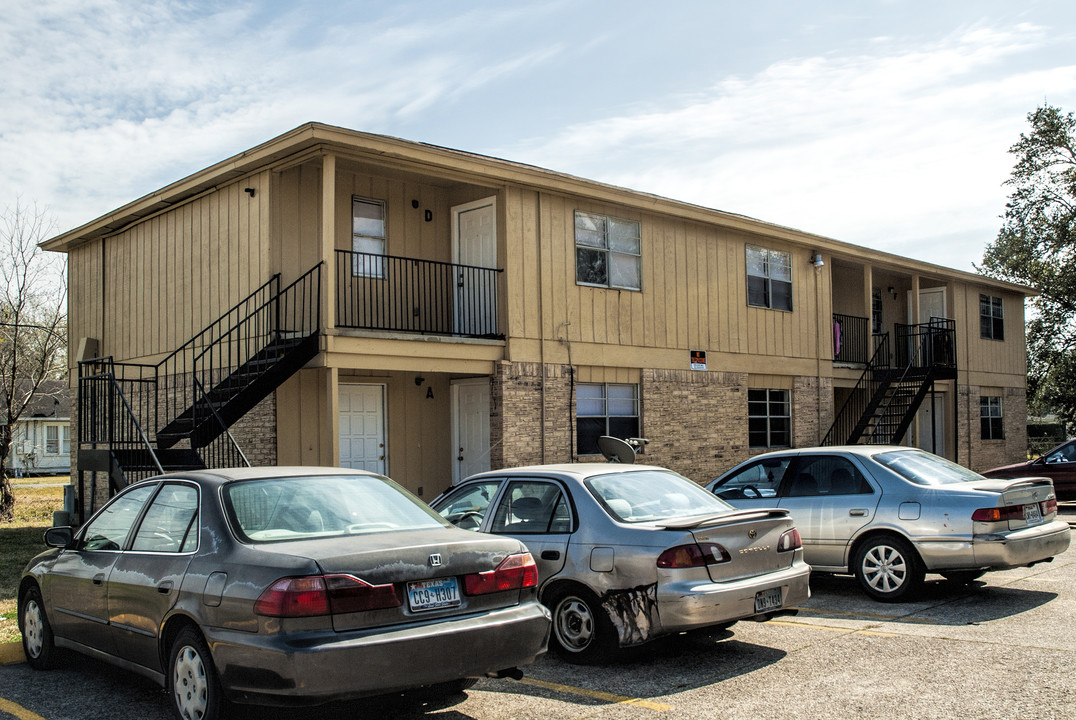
[168,626,224,720]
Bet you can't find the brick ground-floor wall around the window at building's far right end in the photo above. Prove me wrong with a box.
[957,385,1028,471]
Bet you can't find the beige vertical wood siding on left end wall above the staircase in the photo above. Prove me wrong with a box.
[89,173,269,359]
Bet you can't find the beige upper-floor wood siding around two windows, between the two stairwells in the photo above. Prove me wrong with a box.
[506,190,830,358]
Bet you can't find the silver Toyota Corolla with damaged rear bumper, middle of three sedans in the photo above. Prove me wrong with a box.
[431,464,810,663]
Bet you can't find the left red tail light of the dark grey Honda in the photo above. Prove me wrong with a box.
[254,575,402,618]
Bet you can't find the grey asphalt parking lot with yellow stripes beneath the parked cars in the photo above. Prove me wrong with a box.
[0,504,1076,720]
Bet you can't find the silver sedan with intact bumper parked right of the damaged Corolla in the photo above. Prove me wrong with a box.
[707,446,1070,601]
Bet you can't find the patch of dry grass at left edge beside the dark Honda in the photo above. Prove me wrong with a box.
[0,476,69,643]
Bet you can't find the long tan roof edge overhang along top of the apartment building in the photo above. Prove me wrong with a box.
[41,123,1038,296]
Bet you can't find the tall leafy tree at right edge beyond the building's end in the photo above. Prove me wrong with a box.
[978,104,1076,432]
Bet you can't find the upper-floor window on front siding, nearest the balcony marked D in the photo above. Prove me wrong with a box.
[576,212,642,290]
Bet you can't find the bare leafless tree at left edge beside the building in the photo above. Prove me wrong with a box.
[0,202,67,521]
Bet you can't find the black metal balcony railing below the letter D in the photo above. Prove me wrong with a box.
[336,250,505,339]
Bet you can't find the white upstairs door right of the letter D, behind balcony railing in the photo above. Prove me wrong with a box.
[452,197,497,336]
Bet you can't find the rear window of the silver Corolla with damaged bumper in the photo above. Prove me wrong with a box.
[586,470,733,522]
